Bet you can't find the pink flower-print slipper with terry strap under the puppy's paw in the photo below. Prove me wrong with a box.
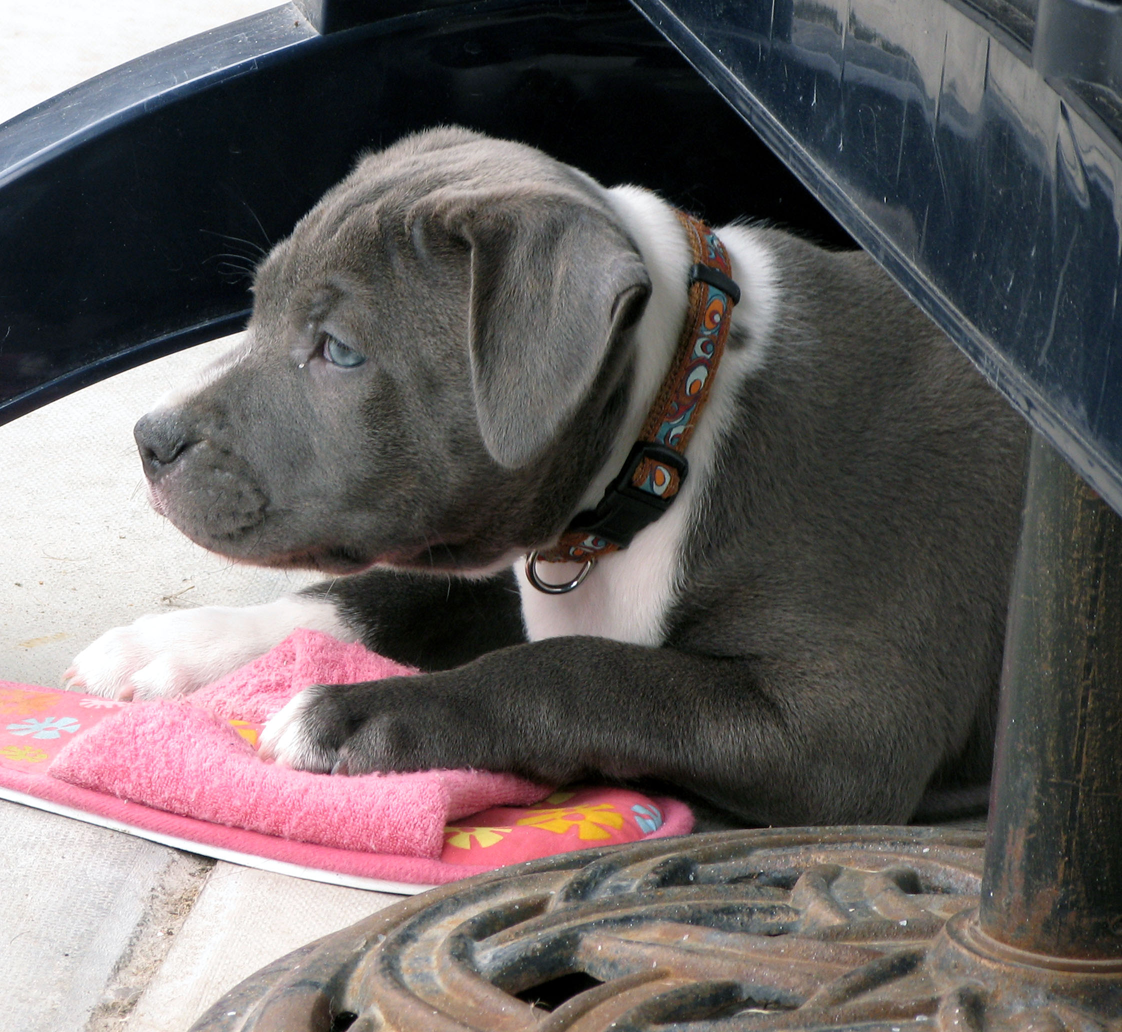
[0,630,692,885]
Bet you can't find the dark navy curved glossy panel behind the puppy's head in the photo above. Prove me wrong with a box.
[0,0,850,420]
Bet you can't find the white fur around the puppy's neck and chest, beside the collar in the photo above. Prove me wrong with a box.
[515,186,776,646]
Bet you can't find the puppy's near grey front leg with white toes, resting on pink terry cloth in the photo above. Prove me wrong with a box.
[263,637,936,824]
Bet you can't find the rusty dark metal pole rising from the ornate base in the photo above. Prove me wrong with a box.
[981,435,1122,960]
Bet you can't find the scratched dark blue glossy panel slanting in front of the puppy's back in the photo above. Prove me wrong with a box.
[636,0,1122,509]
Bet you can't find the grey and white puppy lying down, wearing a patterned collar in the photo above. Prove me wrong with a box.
[68,129,1026,824]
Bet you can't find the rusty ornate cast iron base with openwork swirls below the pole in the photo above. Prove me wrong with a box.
[194,828,1122,1032]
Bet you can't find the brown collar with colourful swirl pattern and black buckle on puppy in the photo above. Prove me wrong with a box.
[526,212,741,595]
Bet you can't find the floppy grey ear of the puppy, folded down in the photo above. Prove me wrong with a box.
[441,190,651,469]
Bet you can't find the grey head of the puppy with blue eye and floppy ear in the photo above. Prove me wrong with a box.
[137,129,650,572]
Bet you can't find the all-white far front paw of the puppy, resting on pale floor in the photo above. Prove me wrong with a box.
[63,597,352,699]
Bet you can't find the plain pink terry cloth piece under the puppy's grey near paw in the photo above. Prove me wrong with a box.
[47,630,551,858]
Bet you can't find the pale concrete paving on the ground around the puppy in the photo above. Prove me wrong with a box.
[0,0,410,1032]
